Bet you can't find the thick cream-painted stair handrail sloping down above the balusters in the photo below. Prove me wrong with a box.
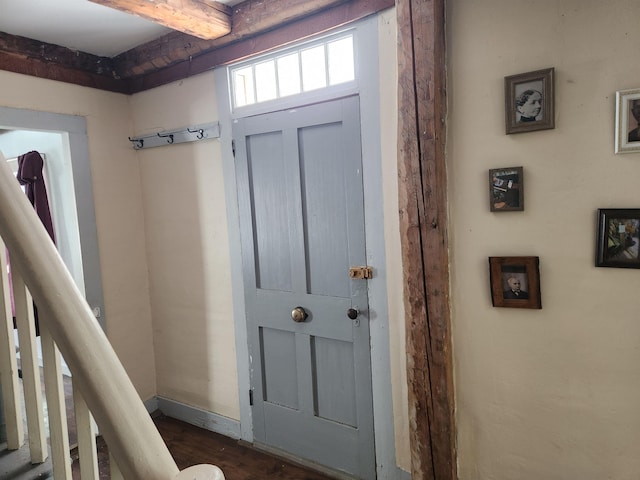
[0,157,224,480]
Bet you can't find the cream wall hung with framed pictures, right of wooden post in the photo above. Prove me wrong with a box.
[447,0,640,480]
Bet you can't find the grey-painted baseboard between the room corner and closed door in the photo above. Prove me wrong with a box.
[154,396,240,440]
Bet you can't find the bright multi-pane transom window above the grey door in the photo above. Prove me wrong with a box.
[230,32,356,108]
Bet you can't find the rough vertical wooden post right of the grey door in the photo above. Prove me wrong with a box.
[396,0,457,480]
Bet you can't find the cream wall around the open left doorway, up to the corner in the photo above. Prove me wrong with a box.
[0,71,156,400]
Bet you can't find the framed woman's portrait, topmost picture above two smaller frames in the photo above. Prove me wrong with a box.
[504,68,555,135]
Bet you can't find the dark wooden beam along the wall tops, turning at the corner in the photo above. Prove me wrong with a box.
[0,0,395,93]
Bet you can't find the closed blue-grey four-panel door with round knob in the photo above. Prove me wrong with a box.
[233,97,376,479]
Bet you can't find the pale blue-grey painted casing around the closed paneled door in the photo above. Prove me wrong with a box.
[214,15,409,480]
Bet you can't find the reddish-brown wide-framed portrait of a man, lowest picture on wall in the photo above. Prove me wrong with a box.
[489,257,542,308]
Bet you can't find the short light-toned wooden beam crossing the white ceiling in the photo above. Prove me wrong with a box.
[89,0,231,40]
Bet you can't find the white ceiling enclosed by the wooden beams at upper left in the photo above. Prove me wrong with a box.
[0,0,238,57]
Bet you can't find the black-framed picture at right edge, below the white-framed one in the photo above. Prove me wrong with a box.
[596,208,640,268]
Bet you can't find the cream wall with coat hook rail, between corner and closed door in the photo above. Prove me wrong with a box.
[130,72,240,420]
